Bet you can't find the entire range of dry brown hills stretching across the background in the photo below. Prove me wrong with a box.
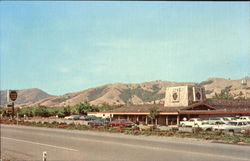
[0,78,250,106]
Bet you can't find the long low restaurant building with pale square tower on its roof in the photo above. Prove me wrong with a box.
[89,86,250,125]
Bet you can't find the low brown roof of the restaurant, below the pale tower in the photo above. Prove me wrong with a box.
[90,100,250,115]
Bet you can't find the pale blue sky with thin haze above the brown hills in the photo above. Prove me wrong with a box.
[0,1,250,95]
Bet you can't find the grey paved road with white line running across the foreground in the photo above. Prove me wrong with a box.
[1,125,250,161]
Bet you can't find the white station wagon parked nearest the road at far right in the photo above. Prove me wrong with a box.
[214,121,249,133]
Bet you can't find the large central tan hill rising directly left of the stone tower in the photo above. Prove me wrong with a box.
[25,81,195,106]
